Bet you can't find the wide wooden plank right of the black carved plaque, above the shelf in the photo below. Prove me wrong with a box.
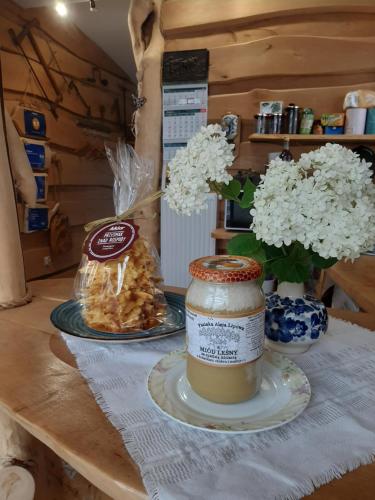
[209,36,375,87]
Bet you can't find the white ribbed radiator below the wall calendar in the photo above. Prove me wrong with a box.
[160,194,217,288]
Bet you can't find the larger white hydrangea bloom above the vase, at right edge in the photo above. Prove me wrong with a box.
[251,144,375,259]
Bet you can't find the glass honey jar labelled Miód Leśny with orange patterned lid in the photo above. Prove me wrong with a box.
[186,256,264,403]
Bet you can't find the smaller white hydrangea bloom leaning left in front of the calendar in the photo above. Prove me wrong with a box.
[164,124,234,215]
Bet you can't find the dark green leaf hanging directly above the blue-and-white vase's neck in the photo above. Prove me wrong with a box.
[270,242,311,283]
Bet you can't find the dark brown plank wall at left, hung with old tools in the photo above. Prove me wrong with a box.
[0,0,135,279]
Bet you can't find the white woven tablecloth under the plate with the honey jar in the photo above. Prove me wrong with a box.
[63,318,375,500]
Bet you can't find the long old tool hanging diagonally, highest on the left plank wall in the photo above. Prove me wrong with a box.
[8,19,63,119]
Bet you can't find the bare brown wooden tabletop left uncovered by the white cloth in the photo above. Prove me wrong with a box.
[0,278,375,500]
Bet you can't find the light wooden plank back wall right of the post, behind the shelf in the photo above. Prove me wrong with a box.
[162,0,375,251]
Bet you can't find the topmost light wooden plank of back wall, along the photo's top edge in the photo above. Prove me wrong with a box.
[162,0,375,39]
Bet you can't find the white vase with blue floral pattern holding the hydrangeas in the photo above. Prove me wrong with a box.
[266,282,328,354]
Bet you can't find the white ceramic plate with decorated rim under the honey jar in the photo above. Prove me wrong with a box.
[148,351,311,433]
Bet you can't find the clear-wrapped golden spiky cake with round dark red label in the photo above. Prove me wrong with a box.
[75,141,166,333]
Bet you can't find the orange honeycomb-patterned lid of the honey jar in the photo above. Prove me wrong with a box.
[189,255,262,283]
